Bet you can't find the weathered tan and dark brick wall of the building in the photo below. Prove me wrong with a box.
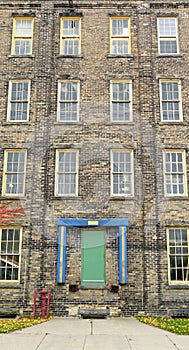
[0,0,189,316]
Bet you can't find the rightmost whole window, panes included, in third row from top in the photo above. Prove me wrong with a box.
[164,150,187,196]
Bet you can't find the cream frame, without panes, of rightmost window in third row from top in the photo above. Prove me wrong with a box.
[163,149,188,197]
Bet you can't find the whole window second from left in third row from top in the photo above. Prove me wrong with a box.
[55,149,78,196]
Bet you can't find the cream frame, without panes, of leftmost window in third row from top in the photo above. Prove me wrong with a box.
[2,149,27,197]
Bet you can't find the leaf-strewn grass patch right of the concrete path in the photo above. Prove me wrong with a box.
[136,317,189,335]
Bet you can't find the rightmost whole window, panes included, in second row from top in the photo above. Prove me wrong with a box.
[160,80,183,122]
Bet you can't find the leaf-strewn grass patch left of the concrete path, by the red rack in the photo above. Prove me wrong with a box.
[0,318,50,333]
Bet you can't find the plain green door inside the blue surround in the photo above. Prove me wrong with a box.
[81,230,105,285]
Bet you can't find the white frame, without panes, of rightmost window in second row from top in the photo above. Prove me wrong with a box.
[159,79,183,123]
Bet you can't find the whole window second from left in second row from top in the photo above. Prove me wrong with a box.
[57,80,80,122]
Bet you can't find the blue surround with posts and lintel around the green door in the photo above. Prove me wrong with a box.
[57,218,128,284]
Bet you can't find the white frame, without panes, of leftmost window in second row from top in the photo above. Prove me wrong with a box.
[7,79,31,123]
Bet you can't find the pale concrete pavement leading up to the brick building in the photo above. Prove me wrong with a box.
[0,318,189,350]
